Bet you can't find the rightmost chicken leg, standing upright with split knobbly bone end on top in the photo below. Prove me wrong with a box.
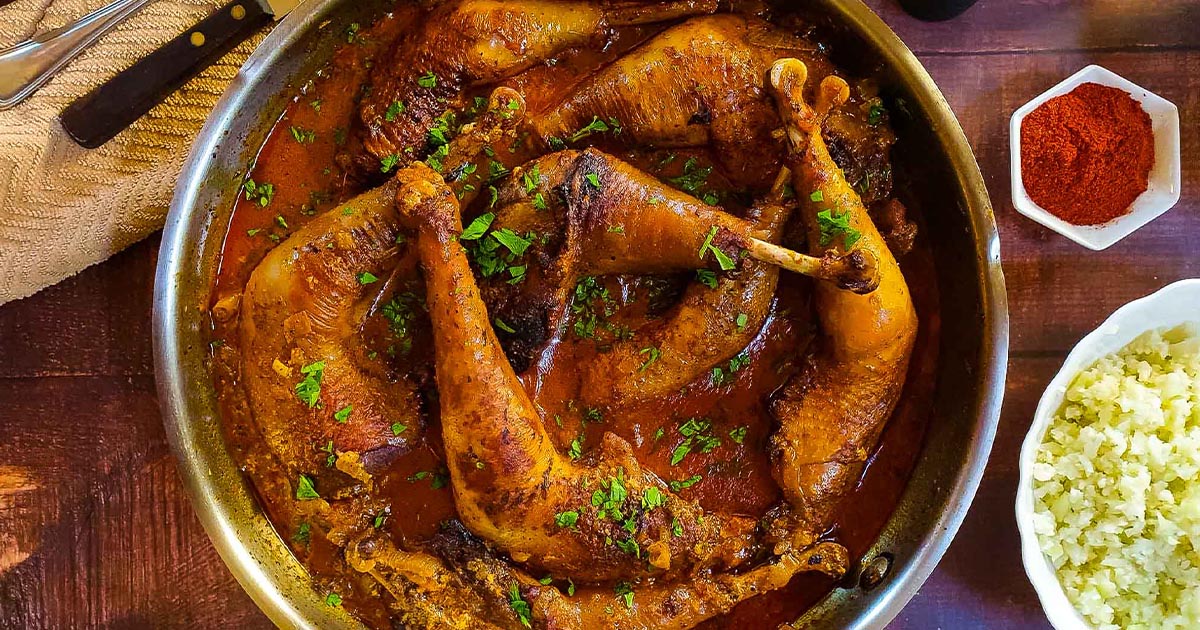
[770,59,917,532]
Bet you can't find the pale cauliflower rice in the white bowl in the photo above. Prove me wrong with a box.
[1033,325,1200,629]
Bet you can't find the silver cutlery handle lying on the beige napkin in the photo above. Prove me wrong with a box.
[0,0,152,109]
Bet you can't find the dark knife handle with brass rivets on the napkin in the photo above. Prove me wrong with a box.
[61,0,271,149]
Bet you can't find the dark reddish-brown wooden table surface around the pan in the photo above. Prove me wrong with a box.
[0,0,1200,629]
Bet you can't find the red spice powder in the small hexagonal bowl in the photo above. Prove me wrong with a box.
[1021,83,1154,226]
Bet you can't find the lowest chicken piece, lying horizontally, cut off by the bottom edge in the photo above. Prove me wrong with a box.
[346,508,850,630]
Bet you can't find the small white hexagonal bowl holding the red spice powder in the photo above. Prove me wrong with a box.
[1008,66,1181,250]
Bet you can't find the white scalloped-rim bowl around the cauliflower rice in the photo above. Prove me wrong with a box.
[1016,278,1200,630]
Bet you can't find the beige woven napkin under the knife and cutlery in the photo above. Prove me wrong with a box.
[0,0,263,304]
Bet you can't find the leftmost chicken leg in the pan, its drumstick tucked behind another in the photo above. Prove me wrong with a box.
[240,88,523,487]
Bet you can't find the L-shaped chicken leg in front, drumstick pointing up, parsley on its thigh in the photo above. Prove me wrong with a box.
[396,164,756,580]
